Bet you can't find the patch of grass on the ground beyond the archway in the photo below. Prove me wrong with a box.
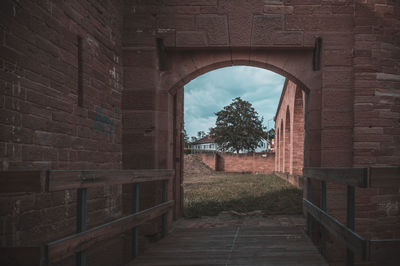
[184,173,303,217]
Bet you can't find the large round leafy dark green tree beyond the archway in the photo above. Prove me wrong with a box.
[210,97,265,153]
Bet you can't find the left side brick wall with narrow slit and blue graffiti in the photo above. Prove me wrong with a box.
[0,0,124,265]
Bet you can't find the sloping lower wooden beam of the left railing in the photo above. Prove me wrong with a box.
[47,200,174,265]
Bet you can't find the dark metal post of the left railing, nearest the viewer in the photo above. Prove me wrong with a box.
[76,188,87,266]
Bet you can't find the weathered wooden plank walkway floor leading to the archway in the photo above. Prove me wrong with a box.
[129,215,327,266]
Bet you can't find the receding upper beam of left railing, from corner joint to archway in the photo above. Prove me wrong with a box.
[48,169,174,191]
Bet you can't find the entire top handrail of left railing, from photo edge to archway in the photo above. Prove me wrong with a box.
[0,169,175,193]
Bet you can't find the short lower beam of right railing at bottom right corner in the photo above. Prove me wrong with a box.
[368,239,400,265]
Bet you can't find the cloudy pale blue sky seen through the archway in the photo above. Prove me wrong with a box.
[184,66,285,137]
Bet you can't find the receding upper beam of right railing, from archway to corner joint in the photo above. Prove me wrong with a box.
[303,167,368,187]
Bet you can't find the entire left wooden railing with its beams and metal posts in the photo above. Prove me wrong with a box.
[0,169,174,266]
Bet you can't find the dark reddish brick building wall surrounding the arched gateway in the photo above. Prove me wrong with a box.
[0,0,400,265]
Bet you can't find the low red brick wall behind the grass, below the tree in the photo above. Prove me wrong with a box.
[199,153,275,174]
